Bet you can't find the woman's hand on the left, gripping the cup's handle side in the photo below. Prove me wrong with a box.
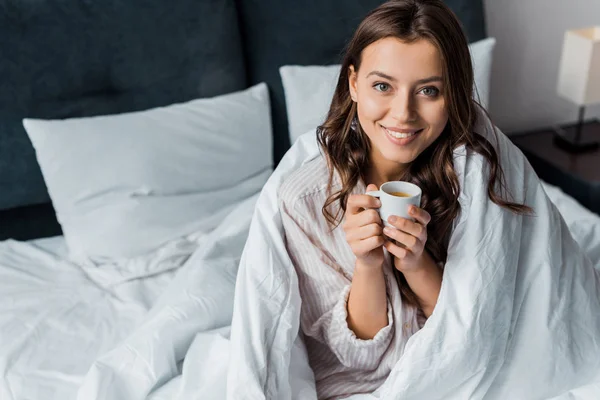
[343,184,385,268]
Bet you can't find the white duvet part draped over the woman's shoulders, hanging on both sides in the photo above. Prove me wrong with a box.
[227,122,600,400]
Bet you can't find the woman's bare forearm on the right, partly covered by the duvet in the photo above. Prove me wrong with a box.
[402,251,442,318]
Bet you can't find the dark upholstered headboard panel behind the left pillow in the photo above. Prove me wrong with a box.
[0,0,246,209]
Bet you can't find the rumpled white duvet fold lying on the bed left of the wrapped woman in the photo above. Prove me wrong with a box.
[77,194,258,400]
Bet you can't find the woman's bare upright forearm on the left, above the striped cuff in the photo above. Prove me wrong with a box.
[347,261,389,340]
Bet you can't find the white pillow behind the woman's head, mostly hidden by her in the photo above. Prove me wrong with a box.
[279,38,496,143]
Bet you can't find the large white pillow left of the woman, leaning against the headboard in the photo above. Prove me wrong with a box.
[23,83,272,262]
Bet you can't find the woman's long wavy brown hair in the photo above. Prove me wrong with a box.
[317,0,531,304]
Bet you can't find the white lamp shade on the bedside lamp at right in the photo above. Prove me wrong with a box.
[557,26,600,106]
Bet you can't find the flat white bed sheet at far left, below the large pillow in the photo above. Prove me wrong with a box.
[0,236,180,400]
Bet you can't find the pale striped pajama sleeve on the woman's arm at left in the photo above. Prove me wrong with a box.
[279,193,395,369]
